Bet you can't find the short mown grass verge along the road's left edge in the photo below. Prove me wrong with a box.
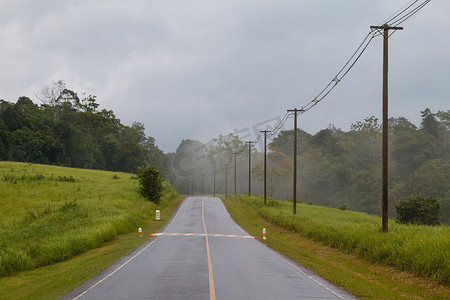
[0,197,182,300]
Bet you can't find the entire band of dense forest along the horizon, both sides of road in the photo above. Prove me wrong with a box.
[0,81,450,224]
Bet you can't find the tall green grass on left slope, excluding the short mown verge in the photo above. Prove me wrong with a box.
[0,162,178,276]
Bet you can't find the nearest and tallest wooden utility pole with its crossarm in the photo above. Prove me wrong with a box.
[370,24,403,232]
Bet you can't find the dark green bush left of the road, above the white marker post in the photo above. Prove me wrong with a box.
[138,166,163,203]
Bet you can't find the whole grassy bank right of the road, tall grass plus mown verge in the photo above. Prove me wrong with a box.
[224,195,450,299]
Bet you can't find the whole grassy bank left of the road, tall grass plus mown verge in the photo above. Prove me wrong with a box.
[0,162,181,299]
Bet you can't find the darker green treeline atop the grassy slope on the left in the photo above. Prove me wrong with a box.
[0,81,167,173]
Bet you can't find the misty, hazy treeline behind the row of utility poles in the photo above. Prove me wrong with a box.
[170,109,450,224]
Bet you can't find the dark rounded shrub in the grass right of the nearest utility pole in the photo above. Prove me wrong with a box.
[395,194,441,225]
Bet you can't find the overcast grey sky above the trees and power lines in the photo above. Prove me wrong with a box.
[0,0,450,152]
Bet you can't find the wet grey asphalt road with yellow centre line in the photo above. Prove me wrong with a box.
[61,197,354,299]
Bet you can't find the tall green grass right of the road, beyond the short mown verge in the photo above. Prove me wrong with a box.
[234,196,450,285]
